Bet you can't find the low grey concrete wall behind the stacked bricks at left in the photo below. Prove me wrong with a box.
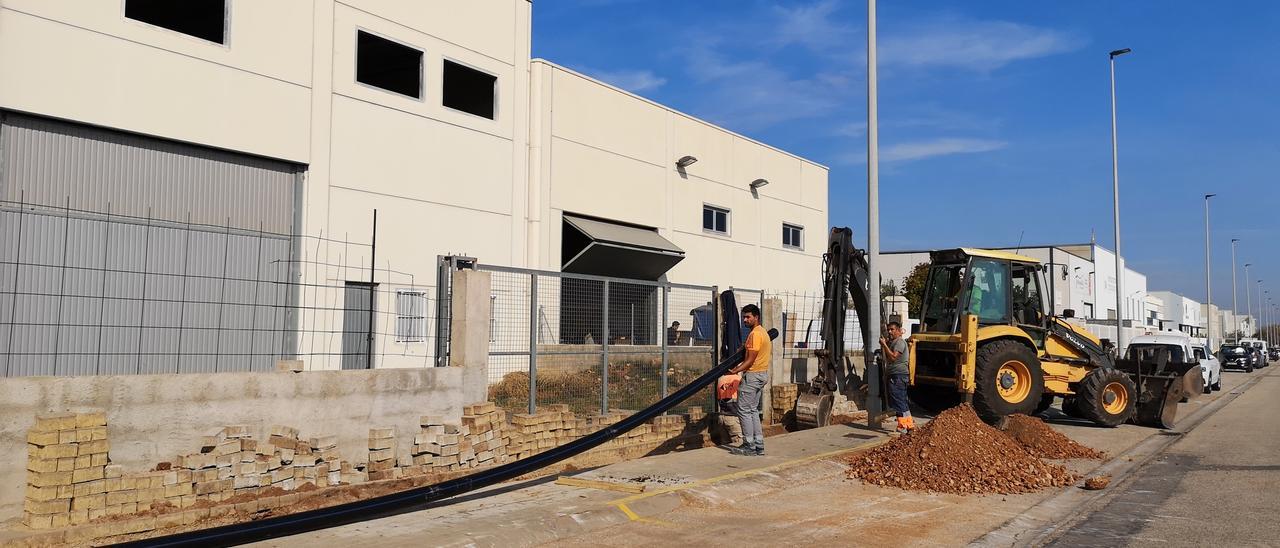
[0,365,486,521]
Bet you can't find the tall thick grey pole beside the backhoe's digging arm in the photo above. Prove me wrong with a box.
[865,0,883,428]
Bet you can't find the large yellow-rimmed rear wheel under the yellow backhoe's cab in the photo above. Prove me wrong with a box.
[973,341,1044,424]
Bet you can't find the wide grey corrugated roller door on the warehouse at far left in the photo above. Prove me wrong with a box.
[0,113,302,376]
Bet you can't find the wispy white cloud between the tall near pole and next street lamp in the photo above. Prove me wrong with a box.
[879,18,1088,72]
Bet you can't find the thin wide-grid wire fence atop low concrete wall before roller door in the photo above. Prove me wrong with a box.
[0,202,435,376]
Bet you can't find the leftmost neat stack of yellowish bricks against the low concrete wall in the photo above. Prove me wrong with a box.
[23,412,110,529]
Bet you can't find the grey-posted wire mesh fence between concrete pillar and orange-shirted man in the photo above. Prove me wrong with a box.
[479,265,718,414]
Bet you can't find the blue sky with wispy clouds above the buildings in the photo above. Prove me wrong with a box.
[534,0,1280,310]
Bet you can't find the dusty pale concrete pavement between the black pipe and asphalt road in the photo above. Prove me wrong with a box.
[264,367,1259,547]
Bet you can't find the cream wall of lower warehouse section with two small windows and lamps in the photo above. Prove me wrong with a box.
[530,60,827,291]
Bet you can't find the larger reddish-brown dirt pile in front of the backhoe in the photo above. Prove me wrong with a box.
[846,405,1076,494]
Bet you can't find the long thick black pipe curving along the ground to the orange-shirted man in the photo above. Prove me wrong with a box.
[119,329,778,547]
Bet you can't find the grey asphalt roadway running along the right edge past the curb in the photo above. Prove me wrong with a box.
[1050,366,1280,547]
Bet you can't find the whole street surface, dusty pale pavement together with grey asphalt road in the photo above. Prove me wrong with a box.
[269,367,1280,547]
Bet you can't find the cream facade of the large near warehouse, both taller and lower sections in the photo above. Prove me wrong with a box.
[0,0,827,373]
